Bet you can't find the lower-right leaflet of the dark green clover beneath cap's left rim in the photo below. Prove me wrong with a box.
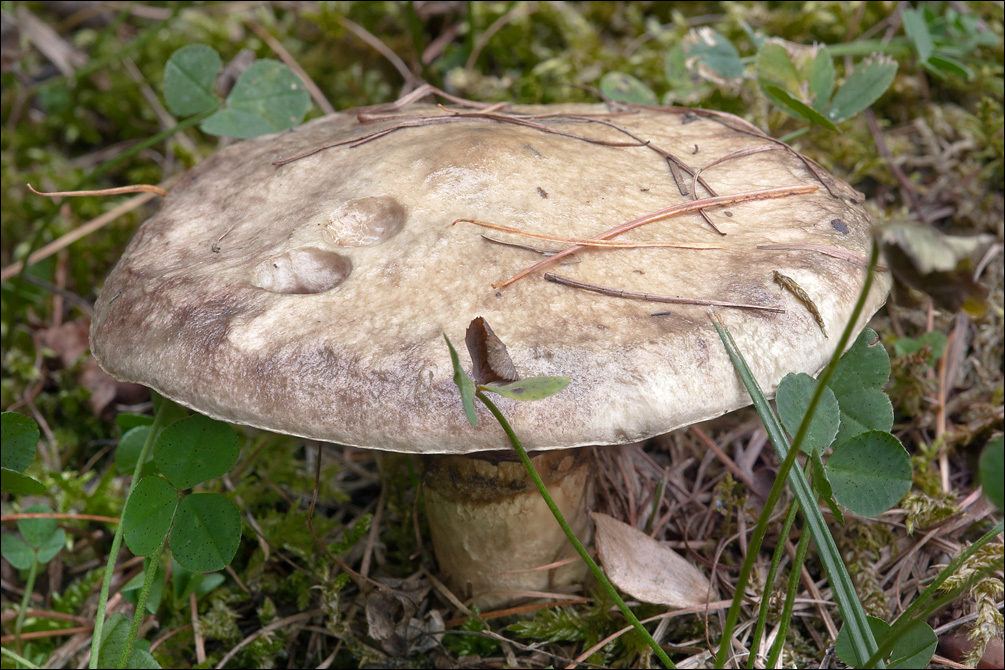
[171,493,241,573]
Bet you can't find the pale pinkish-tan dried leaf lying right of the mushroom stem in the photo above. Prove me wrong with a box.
[591,512,711,608]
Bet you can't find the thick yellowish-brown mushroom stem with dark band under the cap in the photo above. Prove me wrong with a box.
[423,449,593,609]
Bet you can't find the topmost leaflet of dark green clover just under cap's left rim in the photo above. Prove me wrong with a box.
[154,414,240,489]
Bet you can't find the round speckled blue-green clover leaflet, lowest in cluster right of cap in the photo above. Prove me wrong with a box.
[825,430,911,516]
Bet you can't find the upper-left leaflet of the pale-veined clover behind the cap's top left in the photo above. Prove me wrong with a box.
[164,44,223,117]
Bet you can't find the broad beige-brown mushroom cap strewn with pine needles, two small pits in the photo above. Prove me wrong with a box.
[91,104,889,453]
